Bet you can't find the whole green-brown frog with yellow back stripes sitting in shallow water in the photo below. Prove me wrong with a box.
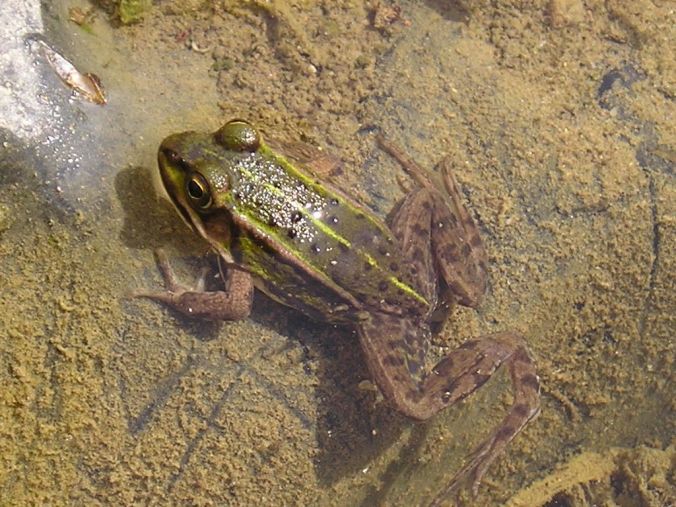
[133,119,540,505]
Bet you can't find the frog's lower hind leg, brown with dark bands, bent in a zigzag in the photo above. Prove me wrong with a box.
[359,313,540,500]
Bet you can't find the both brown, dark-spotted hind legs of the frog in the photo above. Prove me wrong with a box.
[359,139,540,505]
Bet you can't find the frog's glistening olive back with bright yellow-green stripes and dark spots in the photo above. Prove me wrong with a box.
[224,149,428,320]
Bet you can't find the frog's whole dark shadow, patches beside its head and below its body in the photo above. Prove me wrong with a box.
[115,167,425,494]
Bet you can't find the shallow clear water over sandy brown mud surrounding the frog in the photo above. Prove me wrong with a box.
[0,1,676,505]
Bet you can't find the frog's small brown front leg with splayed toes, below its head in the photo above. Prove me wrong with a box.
[131,250,253,320]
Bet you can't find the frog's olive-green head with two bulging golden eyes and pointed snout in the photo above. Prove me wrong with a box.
[157,120,261,260]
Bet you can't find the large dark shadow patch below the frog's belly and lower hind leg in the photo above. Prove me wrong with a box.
[252,295,434,496]
